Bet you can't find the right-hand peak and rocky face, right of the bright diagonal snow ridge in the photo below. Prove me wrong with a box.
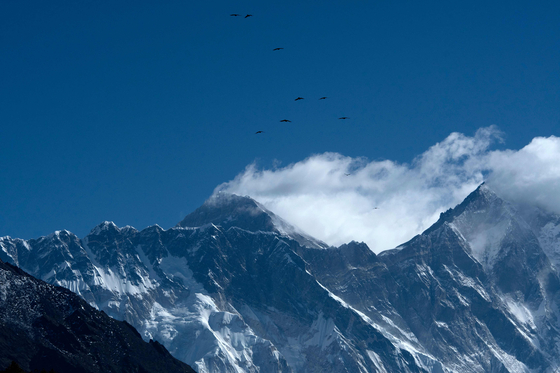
[294,185,560,372]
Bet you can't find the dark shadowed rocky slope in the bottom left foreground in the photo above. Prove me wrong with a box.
[0,261,194,373]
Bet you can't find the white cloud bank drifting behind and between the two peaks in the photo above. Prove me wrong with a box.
[215,126,560,252]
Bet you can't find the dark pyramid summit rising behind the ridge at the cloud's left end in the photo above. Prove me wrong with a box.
[177,192,328,248]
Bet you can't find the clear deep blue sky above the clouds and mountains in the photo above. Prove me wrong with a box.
[0,0,560,238]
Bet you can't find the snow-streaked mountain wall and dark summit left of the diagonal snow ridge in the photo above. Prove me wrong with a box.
[0,199,418,372]
